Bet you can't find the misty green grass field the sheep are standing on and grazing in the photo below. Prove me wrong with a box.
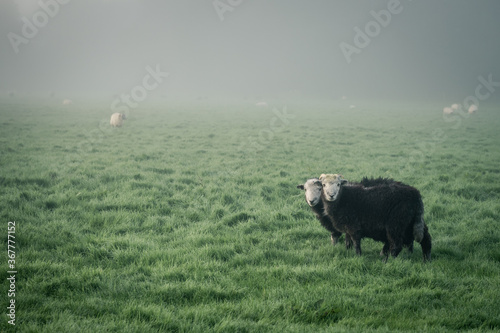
[0,100,500,332]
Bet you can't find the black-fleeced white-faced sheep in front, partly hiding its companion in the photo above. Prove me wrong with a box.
[320,174,432,261]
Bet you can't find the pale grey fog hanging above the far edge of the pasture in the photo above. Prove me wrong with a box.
[0,0,500,103]
